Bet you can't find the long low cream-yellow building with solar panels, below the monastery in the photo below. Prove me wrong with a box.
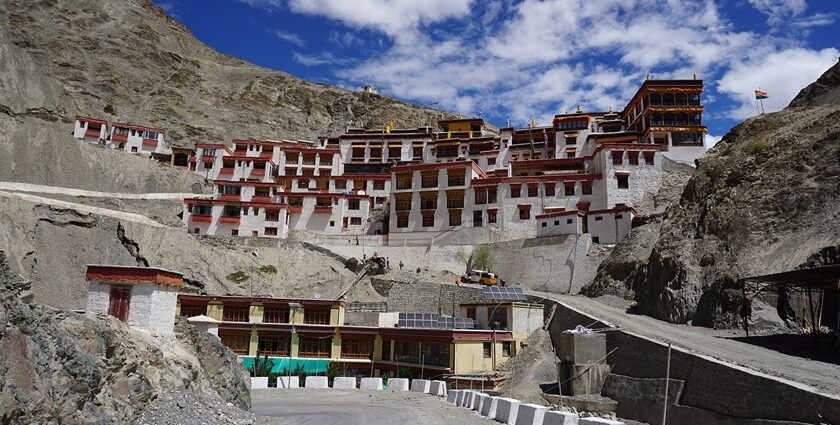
[178,294,543,378]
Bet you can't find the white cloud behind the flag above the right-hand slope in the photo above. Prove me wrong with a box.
[718,48,840,119]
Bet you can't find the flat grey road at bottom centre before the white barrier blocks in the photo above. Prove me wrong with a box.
[251,389,496,425]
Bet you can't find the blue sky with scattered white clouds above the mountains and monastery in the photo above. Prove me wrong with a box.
[155,0,840,143]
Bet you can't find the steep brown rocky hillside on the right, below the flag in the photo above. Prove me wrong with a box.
[584,60,840,328]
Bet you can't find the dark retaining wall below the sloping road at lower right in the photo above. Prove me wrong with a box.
[549,304,840,425]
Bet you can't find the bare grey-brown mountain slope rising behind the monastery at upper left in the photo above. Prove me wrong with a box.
[0,0,448,191]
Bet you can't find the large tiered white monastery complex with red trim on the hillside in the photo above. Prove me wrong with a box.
[179,80,706,245]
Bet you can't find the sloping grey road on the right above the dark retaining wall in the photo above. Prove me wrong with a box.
[534,293,840,402]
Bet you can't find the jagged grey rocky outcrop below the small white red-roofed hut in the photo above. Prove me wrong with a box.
[0,251,250,423]
